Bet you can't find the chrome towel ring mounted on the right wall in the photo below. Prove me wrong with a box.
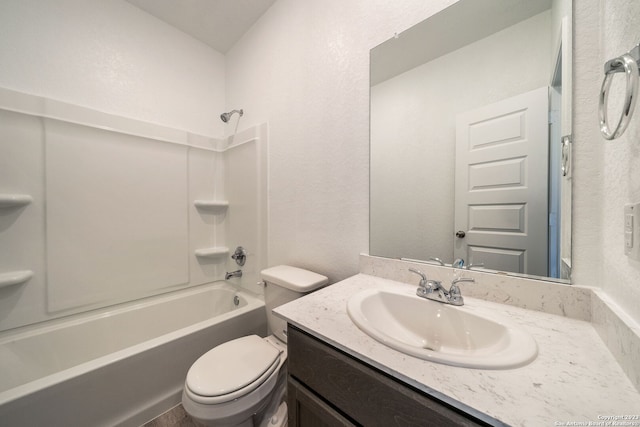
[599,44,640,140]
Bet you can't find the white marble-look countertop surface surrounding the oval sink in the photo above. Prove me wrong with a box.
[274,274,640,427]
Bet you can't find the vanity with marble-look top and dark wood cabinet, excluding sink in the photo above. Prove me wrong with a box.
[275,274,640,426]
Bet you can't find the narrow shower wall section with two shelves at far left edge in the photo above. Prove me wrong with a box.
[0,110,46,330]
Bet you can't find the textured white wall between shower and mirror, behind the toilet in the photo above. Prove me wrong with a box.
[226,0,453,281]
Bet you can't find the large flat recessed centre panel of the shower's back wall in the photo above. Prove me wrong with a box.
[45,120,189,311]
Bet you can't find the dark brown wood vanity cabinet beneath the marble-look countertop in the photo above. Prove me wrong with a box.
[287,325,487,427]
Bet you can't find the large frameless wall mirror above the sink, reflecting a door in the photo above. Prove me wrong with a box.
[369,0,572,282]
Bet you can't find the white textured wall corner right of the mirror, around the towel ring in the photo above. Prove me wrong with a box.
[573,0,640,322]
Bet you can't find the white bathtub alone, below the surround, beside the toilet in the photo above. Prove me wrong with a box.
[0,282,266,427]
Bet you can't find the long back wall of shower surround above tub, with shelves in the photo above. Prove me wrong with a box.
[0,88,230,331]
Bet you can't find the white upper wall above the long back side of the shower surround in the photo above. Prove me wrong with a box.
[0,0,225,136]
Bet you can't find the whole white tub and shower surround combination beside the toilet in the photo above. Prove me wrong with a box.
[0,89,267,426]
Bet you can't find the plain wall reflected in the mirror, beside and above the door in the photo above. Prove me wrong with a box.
[370,11,551,263]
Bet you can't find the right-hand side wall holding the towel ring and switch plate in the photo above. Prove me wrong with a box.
[590,0,640,322]
